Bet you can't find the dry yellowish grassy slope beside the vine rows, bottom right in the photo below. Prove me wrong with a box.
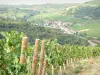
[63,57,100,75]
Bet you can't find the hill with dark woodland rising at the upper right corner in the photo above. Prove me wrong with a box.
[74,0,100,19]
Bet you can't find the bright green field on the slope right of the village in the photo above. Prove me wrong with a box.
[72,21,100,37]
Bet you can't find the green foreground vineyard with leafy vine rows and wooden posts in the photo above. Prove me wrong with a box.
[0,31,100,75]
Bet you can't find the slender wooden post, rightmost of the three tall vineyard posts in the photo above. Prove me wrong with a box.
[38,40,45,75]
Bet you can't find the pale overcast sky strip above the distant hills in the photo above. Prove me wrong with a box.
[0,0,90,5]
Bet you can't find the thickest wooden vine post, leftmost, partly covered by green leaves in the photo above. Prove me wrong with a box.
[20,36,28,64]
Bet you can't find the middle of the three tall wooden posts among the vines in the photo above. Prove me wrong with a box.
[32,39,40,75]
